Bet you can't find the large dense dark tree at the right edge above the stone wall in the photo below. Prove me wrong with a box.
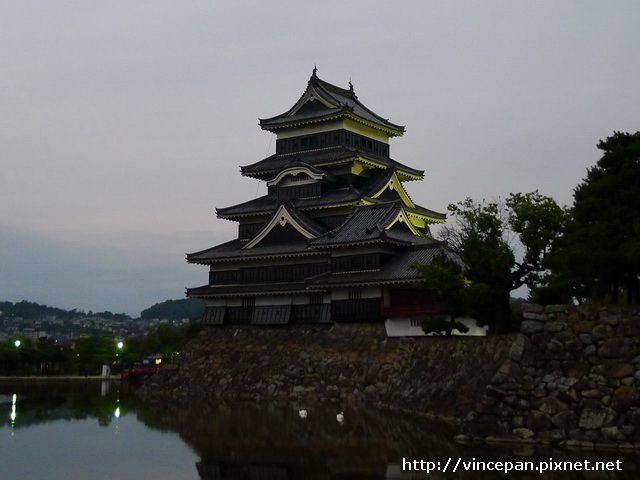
[550,132,640,304]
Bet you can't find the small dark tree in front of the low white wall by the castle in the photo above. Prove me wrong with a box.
[410,254,469,337]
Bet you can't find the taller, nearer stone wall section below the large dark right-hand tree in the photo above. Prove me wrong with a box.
[467,305,640,448]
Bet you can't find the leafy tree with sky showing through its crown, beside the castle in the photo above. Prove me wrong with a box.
[442,190,566,333]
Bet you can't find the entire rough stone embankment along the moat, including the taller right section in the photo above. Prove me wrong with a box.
[140,305,640,448]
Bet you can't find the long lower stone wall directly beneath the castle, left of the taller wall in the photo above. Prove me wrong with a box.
[140,323,514,418]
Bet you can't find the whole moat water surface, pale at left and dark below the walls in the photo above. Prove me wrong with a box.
[0,382,640,480]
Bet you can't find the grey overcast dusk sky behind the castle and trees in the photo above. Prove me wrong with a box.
[0,0,640,316]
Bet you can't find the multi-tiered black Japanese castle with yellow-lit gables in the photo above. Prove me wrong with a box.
[187,68,452,325]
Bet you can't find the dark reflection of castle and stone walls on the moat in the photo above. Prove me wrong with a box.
[148,403,637,480]
